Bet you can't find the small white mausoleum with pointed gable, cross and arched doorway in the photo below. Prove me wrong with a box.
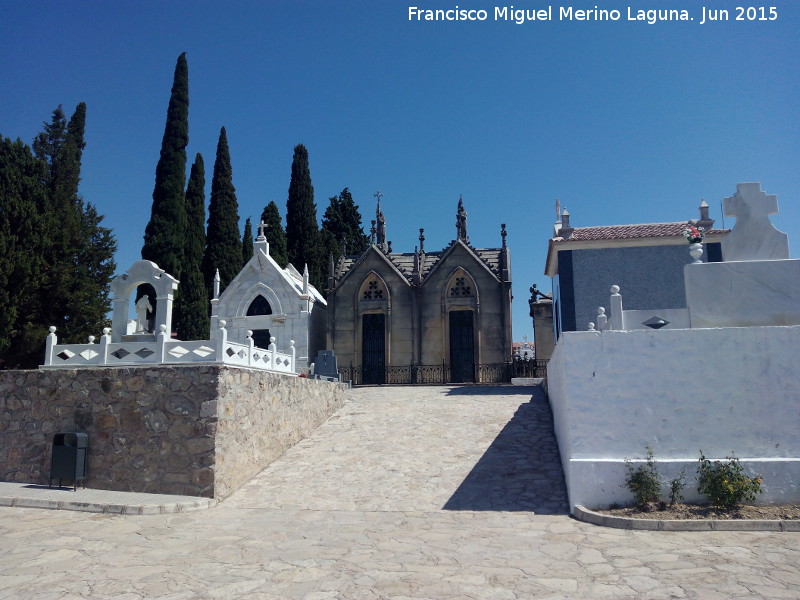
[211,223,327,366]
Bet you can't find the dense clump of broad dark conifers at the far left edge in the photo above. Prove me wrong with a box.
[0,103,116,368]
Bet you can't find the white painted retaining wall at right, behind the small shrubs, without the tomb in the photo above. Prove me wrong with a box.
[547,326,800,507]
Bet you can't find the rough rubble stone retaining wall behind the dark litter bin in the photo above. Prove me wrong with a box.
[0,366,344,499]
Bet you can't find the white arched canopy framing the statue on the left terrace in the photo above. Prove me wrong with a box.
[111,260,179,342]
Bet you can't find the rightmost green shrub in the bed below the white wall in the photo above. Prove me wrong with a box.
[697,450,763,510]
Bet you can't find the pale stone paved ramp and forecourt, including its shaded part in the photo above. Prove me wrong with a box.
[0,387,800,600]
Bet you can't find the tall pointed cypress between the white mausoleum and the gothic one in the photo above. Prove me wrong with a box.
[286,144,324,289]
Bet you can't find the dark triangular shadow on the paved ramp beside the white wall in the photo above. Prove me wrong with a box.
[443,387,569,515]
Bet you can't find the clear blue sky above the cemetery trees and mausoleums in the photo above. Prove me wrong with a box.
[0,0,800,341]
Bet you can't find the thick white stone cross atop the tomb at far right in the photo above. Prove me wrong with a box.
[722,183,789,261]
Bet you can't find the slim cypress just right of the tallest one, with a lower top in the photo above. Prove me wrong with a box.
[176,153,209,340]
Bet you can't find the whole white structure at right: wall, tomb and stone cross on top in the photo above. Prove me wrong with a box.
[547,183,800,508]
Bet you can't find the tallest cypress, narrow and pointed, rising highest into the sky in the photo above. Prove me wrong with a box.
[142,52,189,279]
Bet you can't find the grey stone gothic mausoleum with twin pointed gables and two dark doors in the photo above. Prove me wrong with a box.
[328,194,511,384]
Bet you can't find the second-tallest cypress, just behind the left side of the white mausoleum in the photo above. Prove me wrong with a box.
[203,127,242,291]
